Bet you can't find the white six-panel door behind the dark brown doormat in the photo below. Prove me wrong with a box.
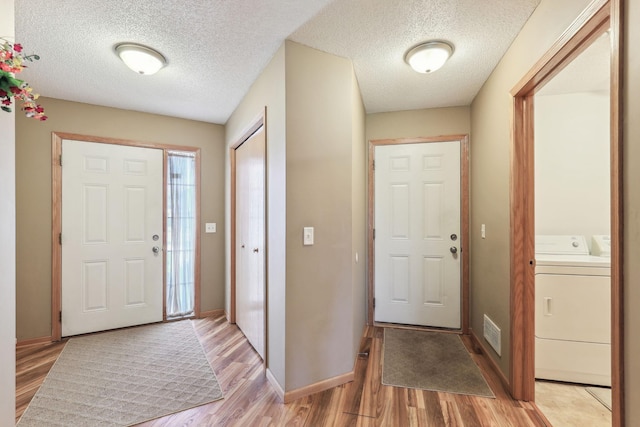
[374,141,461,329]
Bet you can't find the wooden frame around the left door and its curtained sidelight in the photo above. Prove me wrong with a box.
[51,132,201,341]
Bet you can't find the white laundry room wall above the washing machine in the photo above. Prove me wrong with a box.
[535,92,610,242]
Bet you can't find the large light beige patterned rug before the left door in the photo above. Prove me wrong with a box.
[18,320,222,427]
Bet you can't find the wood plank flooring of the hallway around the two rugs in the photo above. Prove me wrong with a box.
[16,316,545,427]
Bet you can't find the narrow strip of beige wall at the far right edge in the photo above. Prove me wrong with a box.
[622,0,640,426]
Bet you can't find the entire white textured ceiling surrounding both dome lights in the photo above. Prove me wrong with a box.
[15,0,540,123]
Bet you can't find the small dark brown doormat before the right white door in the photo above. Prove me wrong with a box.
[382,328,495,398]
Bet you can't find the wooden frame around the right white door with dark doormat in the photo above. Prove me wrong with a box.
[367,134,471,334]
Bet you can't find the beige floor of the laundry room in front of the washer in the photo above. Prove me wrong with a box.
[536,381,611,427]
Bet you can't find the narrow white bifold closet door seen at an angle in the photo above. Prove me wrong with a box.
[236,127,266,360]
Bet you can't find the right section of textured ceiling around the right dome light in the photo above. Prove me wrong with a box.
[290,0,539,113]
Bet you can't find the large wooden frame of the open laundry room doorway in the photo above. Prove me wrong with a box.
[510,0,624,426]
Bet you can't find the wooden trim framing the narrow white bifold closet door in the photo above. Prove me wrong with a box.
[227,107,269,332]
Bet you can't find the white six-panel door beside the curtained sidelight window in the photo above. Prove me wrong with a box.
[61,140,163,336]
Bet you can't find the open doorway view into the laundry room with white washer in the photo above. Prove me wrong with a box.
[534,32,611,427]
